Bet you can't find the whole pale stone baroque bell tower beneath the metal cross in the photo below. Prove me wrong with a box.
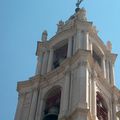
[15,3,120,120]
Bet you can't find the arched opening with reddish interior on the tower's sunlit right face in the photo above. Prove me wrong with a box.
[96,92,108,120]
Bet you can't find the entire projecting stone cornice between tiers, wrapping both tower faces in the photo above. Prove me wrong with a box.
[17,49,117,95]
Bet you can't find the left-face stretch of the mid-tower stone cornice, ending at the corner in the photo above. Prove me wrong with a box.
[17,49,91,92]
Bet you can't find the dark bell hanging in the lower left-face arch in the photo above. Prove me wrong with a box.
[43,106,59,120]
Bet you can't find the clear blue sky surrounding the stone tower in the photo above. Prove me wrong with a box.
[0,0,120,120]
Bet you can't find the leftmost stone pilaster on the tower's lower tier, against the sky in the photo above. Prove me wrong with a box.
[14,94,24,120]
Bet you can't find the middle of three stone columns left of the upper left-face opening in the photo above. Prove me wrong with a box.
[41,50,48,75]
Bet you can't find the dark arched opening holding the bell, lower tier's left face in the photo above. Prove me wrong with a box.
[43,87,61,120]
